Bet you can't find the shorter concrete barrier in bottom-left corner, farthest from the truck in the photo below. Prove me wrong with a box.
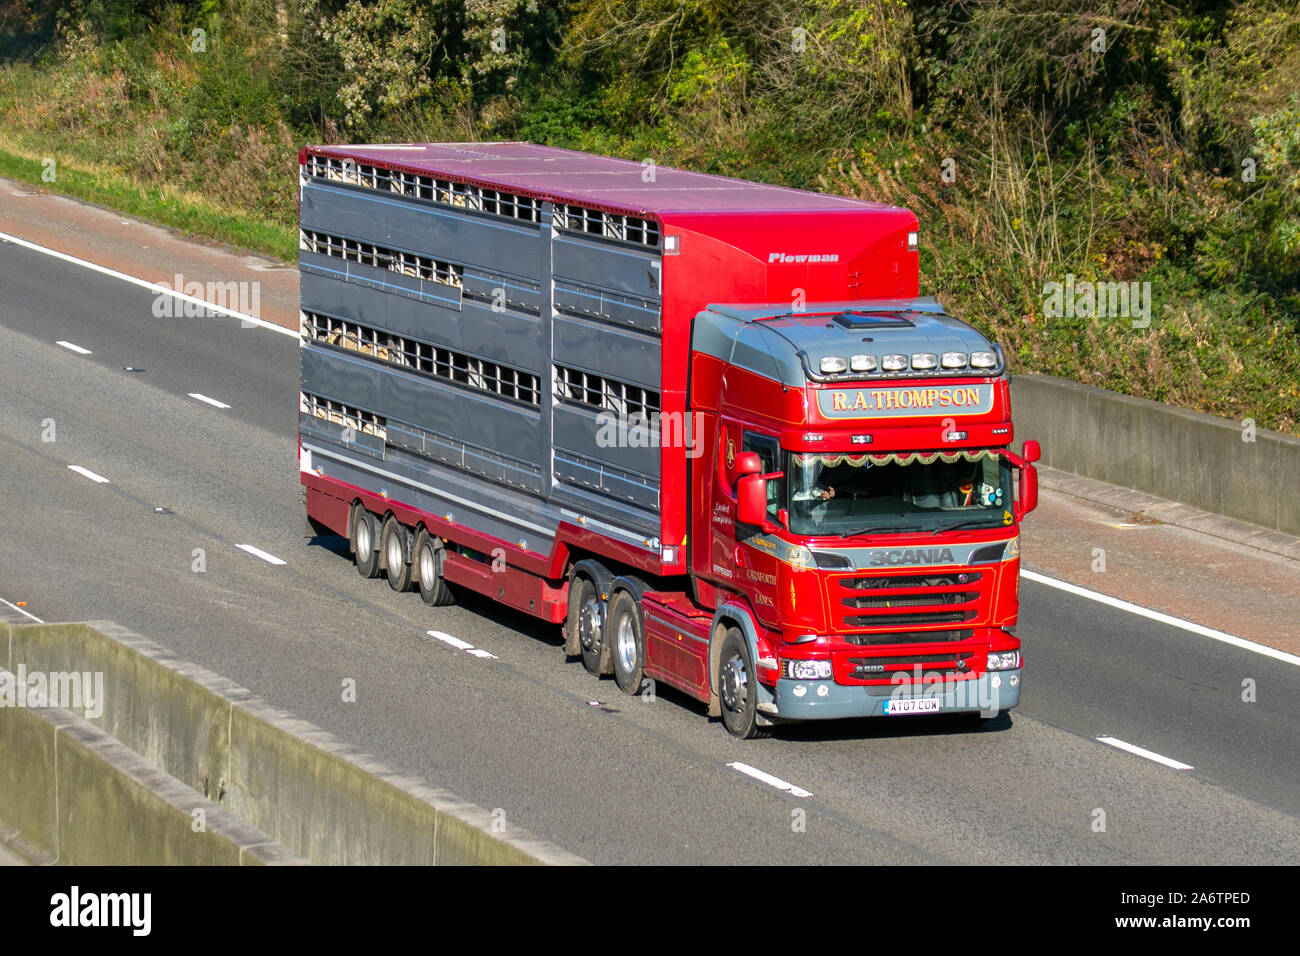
[0,675,307,865]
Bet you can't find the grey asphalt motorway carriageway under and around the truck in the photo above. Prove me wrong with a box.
[0,235,1300,864]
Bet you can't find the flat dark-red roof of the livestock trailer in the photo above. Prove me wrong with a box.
[304,143,898,213]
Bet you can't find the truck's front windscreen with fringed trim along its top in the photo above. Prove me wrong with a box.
[784,450,1011,535]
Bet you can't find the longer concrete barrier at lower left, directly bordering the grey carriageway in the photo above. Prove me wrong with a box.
[0,622,585,865]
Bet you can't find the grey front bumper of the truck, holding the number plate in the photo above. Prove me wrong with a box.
[761,670,1021,721]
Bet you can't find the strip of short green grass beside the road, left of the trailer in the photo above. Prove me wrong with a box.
[0,140,298,263]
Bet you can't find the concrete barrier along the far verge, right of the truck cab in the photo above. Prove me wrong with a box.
[1011,375,1300,535]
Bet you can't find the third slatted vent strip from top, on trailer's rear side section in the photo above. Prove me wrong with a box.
[299,310,542,408]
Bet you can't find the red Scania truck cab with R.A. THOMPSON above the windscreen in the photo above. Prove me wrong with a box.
[690,299,1037,731]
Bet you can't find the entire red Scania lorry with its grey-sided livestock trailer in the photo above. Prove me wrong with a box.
[299,143,1039,737]
